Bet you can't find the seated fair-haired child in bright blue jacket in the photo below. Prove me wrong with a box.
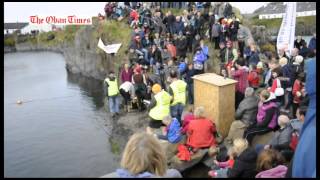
[157,116,182,144]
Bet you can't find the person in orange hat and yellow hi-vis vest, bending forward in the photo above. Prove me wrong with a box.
[147,84,171,131]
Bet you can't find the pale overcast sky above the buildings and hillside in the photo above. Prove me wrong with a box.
[4,2,266,22]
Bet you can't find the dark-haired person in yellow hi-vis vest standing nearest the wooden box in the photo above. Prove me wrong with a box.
[169,70,187,124]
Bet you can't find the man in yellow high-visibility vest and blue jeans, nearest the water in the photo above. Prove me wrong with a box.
[104,71,120,118]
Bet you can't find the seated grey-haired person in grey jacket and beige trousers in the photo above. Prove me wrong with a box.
[225,87,259,145]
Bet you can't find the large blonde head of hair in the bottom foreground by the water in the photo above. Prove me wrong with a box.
[120,132,167,176]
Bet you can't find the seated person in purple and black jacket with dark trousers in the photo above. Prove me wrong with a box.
[243,89,278,144]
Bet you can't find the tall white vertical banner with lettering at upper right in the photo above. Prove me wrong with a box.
[277,2,297,57]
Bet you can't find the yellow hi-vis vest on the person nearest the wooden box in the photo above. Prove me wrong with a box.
[170,80,187,106]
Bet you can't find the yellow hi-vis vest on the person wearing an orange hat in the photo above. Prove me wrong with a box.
[149,90,171,121]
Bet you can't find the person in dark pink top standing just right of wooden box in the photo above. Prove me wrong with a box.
[231,59,248,109]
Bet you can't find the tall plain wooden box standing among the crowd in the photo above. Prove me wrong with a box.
[193,73,237,137]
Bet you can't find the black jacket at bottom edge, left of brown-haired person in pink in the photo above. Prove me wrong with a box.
[227,148,257,178]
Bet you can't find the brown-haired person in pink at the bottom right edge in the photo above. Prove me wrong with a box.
[256,149,288,178]
